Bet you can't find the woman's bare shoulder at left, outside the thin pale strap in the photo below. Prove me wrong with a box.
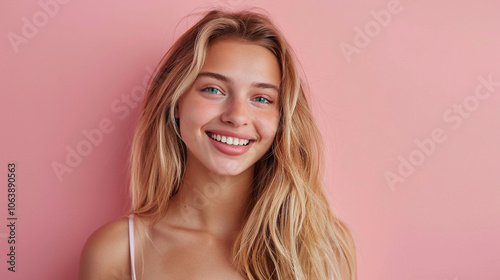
[78,217,130,280]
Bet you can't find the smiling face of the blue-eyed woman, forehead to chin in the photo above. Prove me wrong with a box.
[176,38,281,175]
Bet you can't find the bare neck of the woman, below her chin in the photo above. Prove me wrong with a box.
[167,158,253,237]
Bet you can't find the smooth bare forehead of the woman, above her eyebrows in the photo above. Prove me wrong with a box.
[201,38,281,87]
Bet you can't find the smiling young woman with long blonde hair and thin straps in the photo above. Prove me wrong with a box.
[79,10,356,280]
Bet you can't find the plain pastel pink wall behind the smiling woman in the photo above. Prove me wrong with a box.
[0,0,500,280]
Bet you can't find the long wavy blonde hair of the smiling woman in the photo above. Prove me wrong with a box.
[130,10,356,280]
